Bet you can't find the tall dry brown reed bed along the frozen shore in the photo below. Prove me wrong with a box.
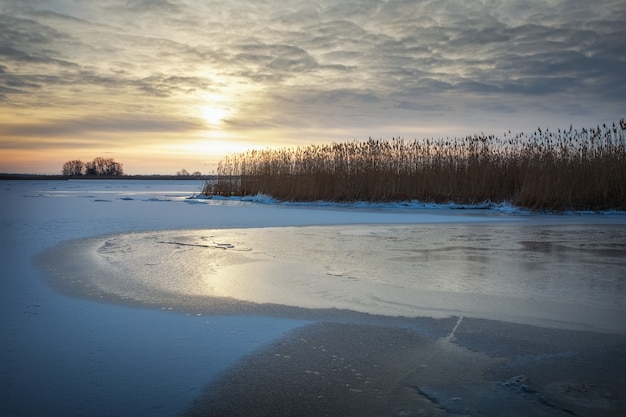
[202,119,626,210]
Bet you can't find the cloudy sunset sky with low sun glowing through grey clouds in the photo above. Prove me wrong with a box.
[0,0,626,174]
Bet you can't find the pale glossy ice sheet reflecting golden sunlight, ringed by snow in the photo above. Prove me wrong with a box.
[41,224,626,332]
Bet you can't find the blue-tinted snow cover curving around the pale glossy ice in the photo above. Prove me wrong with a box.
[0,180,626,416]
